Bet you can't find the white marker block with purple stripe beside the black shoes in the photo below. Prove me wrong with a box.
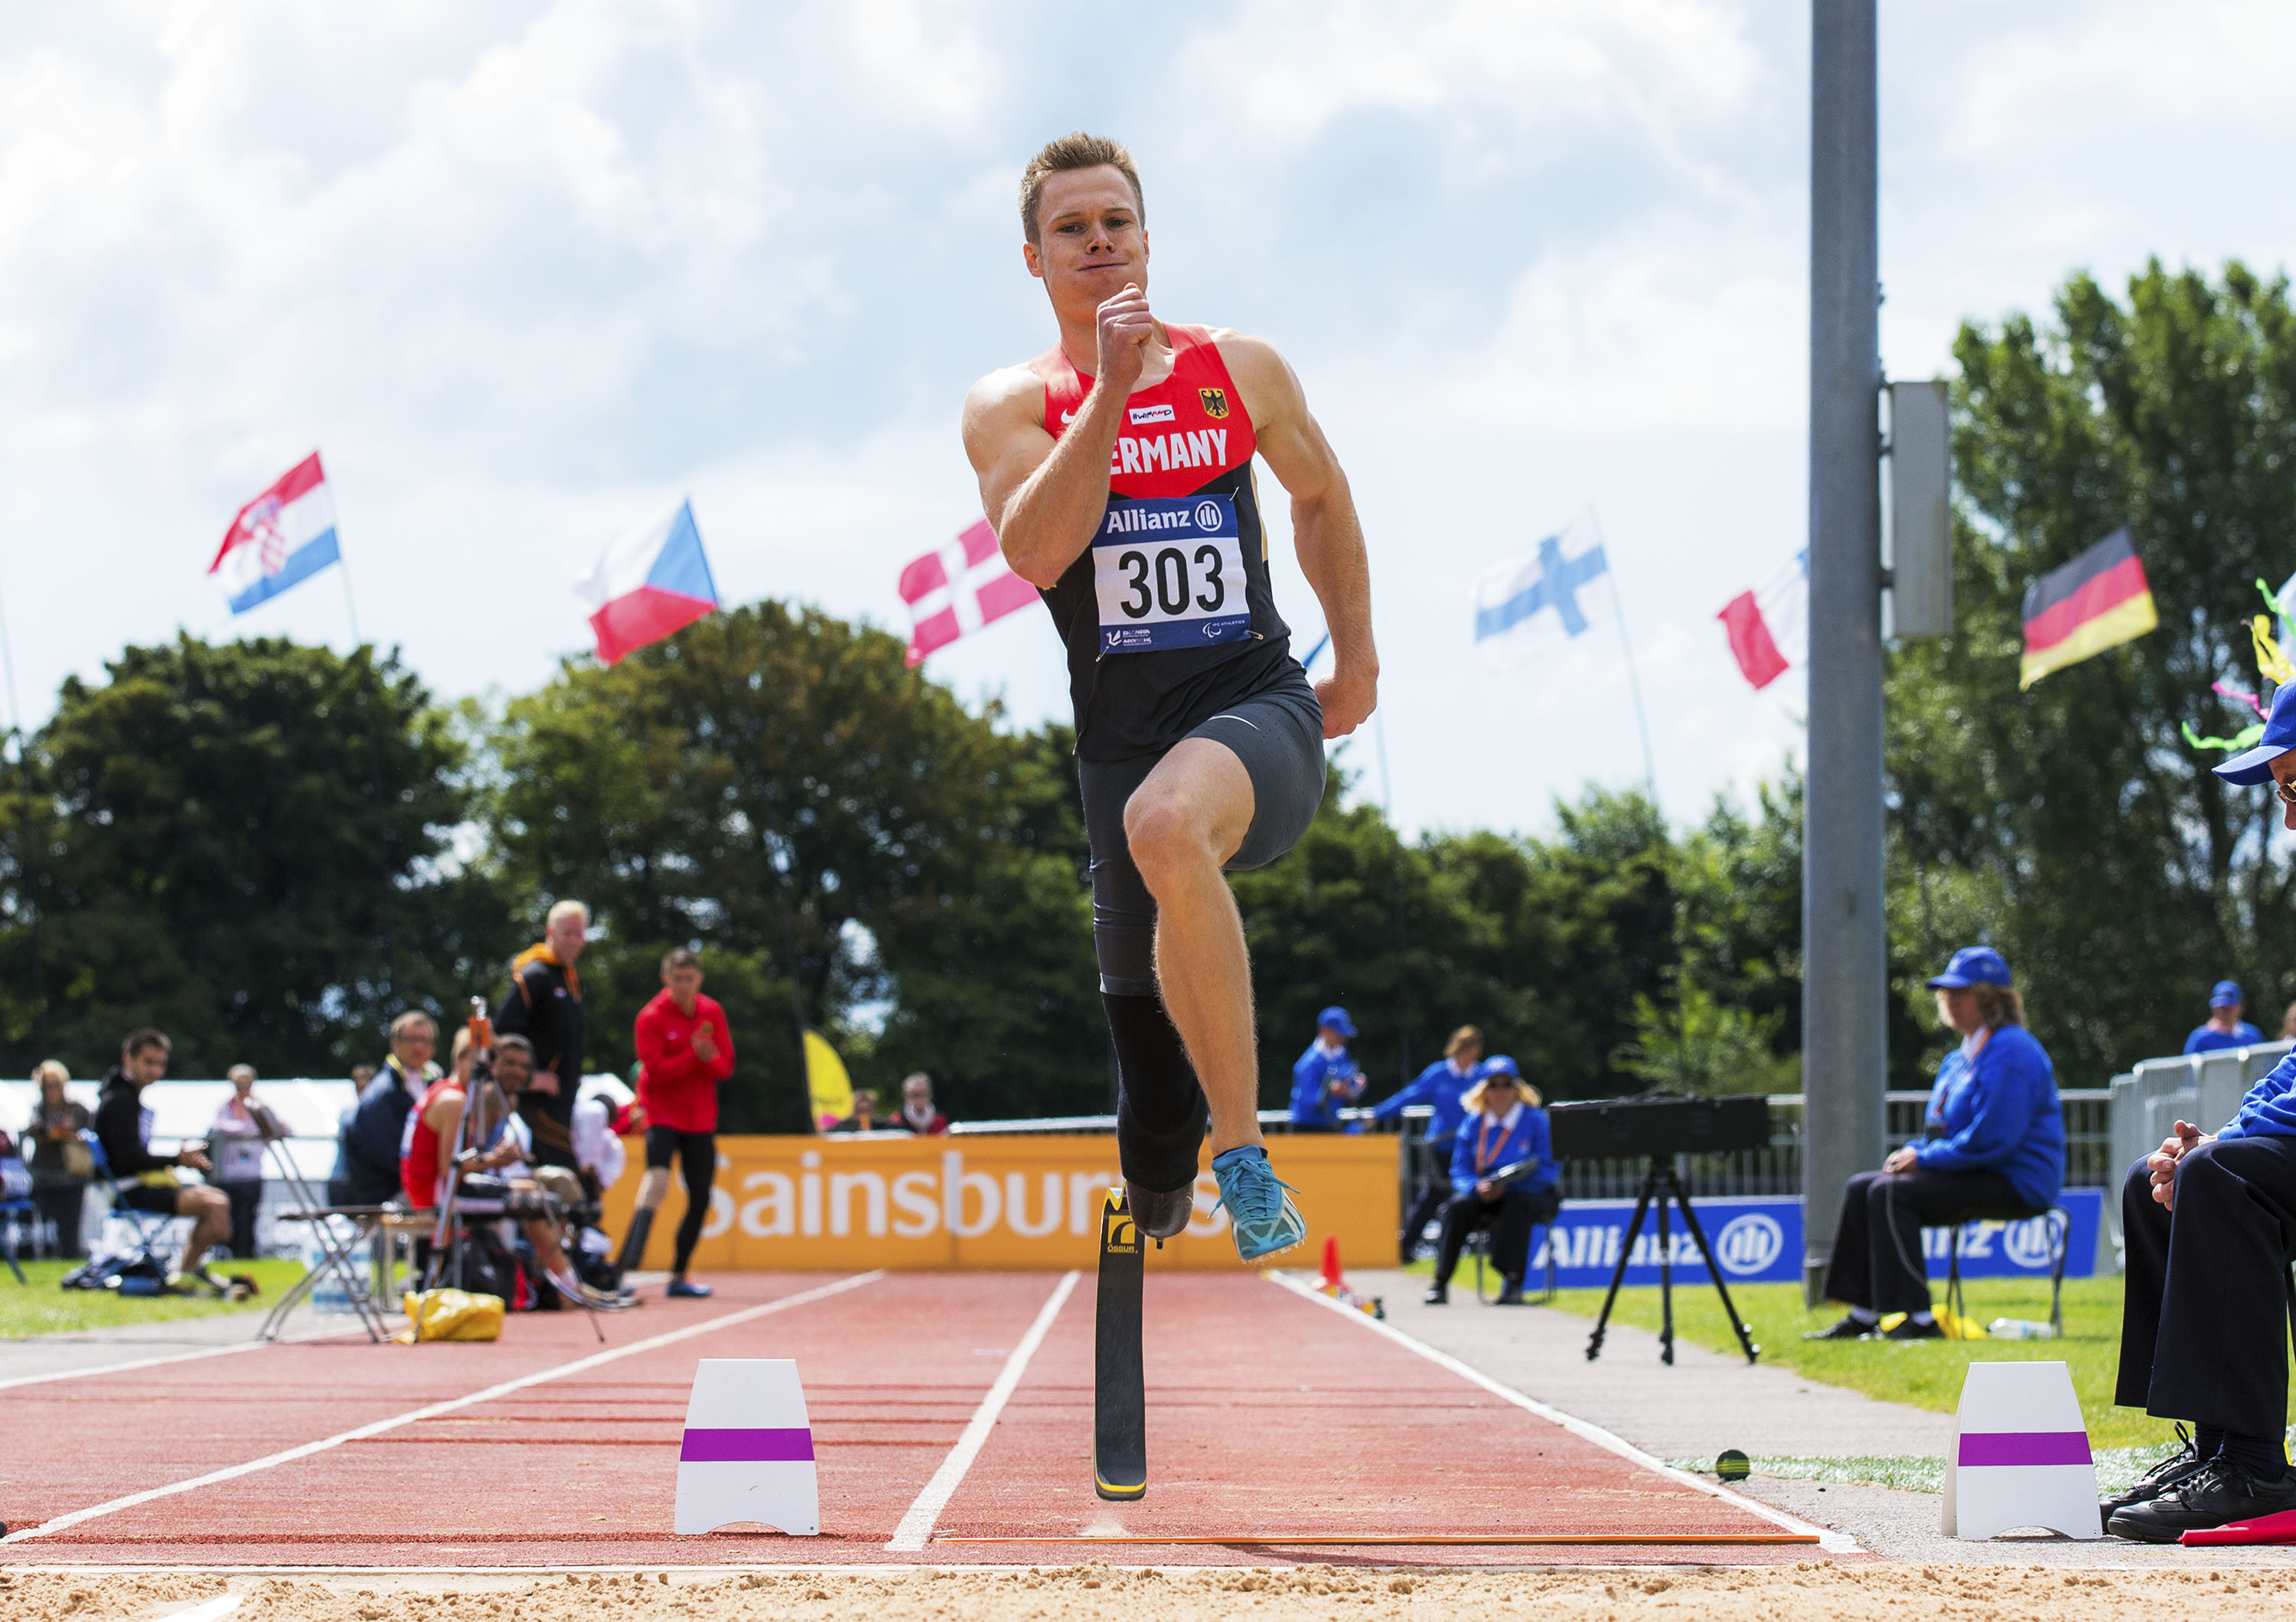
[1938,1363,2103,1539]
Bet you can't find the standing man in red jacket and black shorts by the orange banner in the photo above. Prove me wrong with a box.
[622,947,732,1296]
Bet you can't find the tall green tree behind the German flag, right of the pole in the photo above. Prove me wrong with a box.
[1887,264,2296,1087]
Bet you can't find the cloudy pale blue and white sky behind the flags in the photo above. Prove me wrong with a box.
[0,0,2296,832]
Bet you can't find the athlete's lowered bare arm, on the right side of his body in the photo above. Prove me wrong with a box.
[1219,333,1380,737]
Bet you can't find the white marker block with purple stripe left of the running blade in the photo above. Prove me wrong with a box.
[670,1358,822,1537]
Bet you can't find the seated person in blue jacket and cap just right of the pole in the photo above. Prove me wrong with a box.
[1802,947,2064,1340]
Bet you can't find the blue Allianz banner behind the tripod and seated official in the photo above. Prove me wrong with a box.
[1531,1188,2105,1289]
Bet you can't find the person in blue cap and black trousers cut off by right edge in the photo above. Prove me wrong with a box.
[2101,682,2296,1544]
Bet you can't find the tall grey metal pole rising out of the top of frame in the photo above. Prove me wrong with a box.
[1802,0,1890,1296]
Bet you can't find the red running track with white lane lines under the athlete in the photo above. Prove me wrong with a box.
[0,1273,1818,1567]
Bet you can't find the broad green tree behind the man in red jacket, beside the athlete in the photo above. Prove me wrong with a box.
[494,602,1107,1131]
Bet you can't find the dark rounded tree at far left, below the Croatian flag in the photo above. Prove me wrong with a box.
[0,636,505,1075]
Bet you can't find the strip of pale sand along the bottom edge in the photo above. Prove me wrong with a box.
[13,1551,2296,1622]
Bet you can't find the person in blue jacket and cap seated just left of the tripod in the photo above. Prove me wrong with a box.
[1426,1055,1564,1307]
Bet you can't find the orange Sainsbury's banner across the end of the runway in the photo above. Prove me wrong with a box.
[606,1133,1401,1273]
